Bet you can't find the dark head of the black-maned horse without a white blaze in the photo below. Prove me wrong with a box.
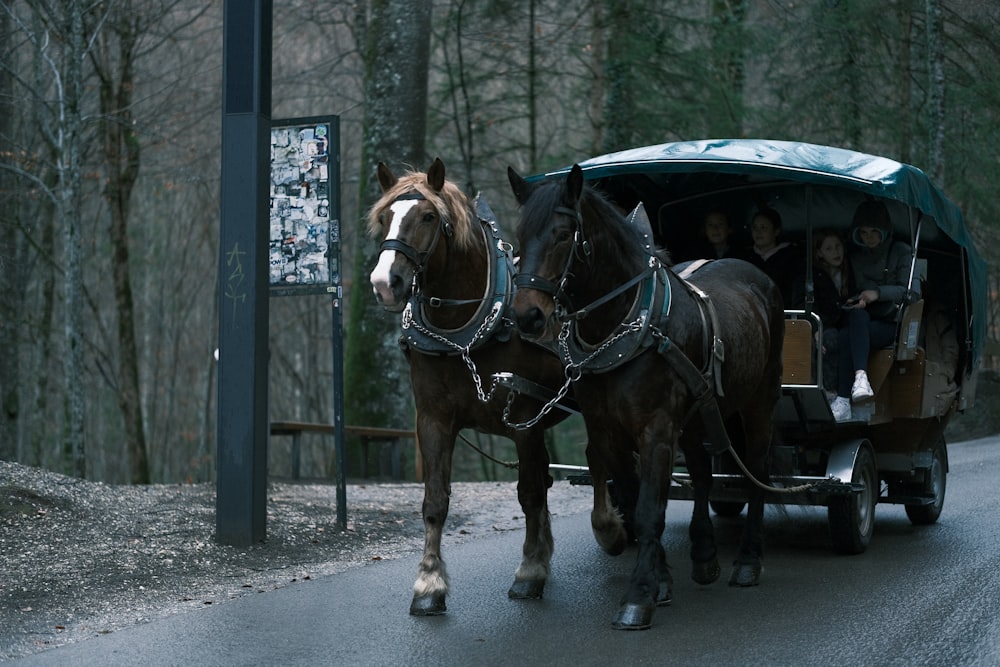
[507,165,590,339]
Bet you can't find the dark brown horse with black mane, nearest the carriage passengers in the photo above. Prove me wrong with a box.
[508,165,784,630]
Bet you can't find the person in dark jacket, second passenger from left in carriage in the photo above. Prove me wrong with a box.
[739,207,805,308]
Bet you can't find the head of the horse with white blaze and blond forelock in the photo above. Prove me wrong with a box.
[368,158,468,312]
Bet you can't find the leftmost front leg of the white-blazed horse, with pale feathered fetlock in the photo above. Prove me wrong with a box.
[410,420,457,616]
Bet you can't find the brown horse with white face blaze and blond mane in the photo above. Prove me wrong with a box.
[368,159,566,616]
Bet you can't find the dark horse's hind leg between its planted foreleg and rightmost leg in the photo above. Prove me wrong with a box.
[683,429,722,585]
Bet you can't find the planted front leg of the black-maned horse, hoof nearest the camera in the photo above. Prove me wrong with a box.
[612,436,674,630]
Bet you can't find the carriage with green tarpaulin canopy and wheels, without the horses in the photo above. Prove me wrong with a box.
[521,140,987,553]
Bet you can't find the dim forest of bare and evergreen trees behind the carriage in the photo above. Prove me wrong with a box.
[0,0,1000,483]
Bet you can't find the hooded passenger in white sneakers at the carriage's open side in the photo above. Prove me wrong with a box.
[830,200,919,421]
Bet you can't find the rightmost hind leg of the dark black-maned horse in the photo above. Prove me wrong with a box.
[729,405,773,587]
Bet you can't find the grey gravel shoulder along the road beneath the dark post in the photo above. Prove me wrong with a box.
[0,461,593,661]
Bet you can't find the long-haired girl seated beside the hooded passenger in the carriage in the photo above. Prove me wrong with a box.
[813,229,854,398]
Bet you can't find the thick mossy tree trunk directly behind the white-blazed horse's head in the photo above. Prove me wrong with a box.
[344,0,431,470]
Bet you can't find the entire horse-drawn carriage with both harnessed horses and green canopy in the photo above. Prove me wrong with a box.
[368,140,986,630]
